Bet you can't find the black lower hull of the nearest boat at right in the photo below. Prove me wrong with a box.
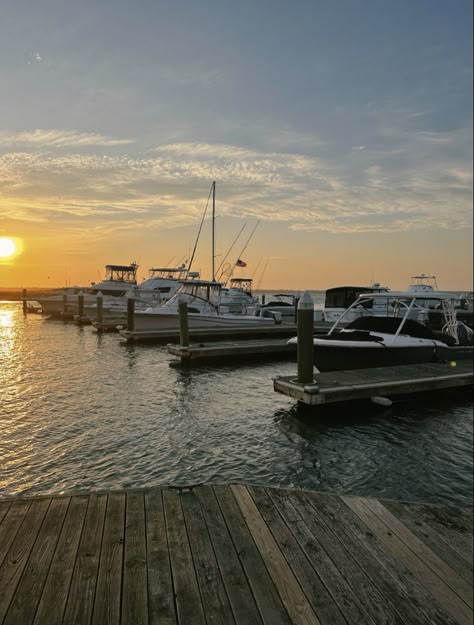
[313,344,473,371]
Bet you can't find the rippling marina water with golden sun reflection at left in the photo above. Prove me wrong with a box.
[0,302,473,507]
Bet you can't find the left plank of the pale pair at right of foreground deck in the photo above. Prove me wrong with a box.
[342,497,472,625]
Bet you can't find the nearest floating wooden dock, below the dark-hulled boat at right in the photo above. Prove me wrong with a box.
[273,359,474,405]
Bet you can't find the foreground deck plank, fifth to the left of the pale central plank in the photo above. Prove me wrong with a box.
[145,489,177,625]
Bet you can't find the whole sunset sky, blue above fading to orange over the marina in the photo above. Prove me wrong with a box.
[0,0,473,290]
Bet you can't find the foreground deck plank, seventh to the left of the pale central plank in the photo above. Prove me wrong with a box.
[92,493,126,625]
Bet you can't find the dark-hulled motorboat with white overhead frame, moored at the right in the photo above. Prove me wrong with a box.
[290,289,473,371]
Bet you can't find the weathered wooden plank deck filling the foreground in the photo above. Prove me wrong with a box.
[0,485,473,625]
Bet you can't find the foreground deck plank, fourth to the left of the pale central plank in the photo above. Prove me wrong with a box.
[163,489,206,625]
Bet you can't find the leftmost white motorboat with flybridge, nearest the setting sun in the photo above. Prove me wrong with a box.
[36,263,138,316]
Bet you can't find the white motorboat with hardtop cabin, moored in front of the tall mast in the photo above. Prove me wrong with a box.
[130,279,281,331]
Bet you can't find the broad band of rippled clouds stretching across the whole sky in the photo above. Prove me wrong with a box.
[0,129,472,236]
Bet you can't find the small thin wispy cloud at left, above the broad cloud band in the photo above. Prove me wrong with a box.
[0,129,134,148]
